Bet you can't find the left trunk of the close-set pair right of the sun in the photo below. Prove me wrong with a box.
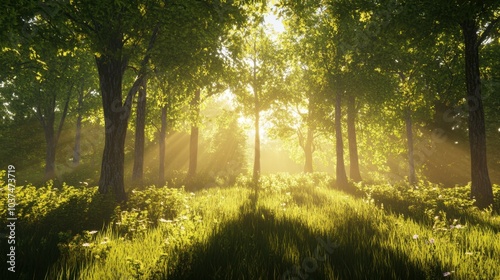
[335,90,349,190]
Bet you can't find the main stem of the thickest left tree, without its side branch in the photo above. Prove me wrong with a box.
[96,51,130,202]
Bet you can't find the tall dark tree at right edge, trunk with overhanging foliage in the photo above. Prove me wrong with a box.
[394,0,500,208]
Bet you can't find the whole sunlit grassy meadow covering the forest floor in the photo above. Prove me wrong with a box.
[0,174,500,280]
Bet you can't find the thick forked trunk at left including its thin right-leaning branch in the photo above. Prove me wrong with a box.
[96,26,159,202]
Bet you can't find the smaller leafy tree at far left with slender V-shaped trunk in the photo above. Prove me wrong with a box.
[3,16,88,180]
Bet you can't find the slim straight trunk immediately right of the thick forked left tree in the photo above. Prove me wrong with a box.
[132,78,147,182]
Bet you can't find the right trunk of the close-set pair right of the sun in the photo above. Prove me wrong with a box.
[347,95,362,182]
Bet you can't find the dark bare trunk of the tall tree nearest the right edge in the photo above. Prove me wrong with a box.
[461,20,493,208]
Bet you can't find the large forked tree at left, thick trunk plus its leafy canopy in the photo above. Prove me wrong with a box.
[58,1,242,201]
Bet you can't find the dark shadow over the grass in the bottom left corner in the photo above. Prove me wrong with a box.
[0,190,115,280]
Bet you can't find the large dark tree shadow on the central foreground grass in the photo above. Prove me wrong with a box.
[161,194,442,279]
